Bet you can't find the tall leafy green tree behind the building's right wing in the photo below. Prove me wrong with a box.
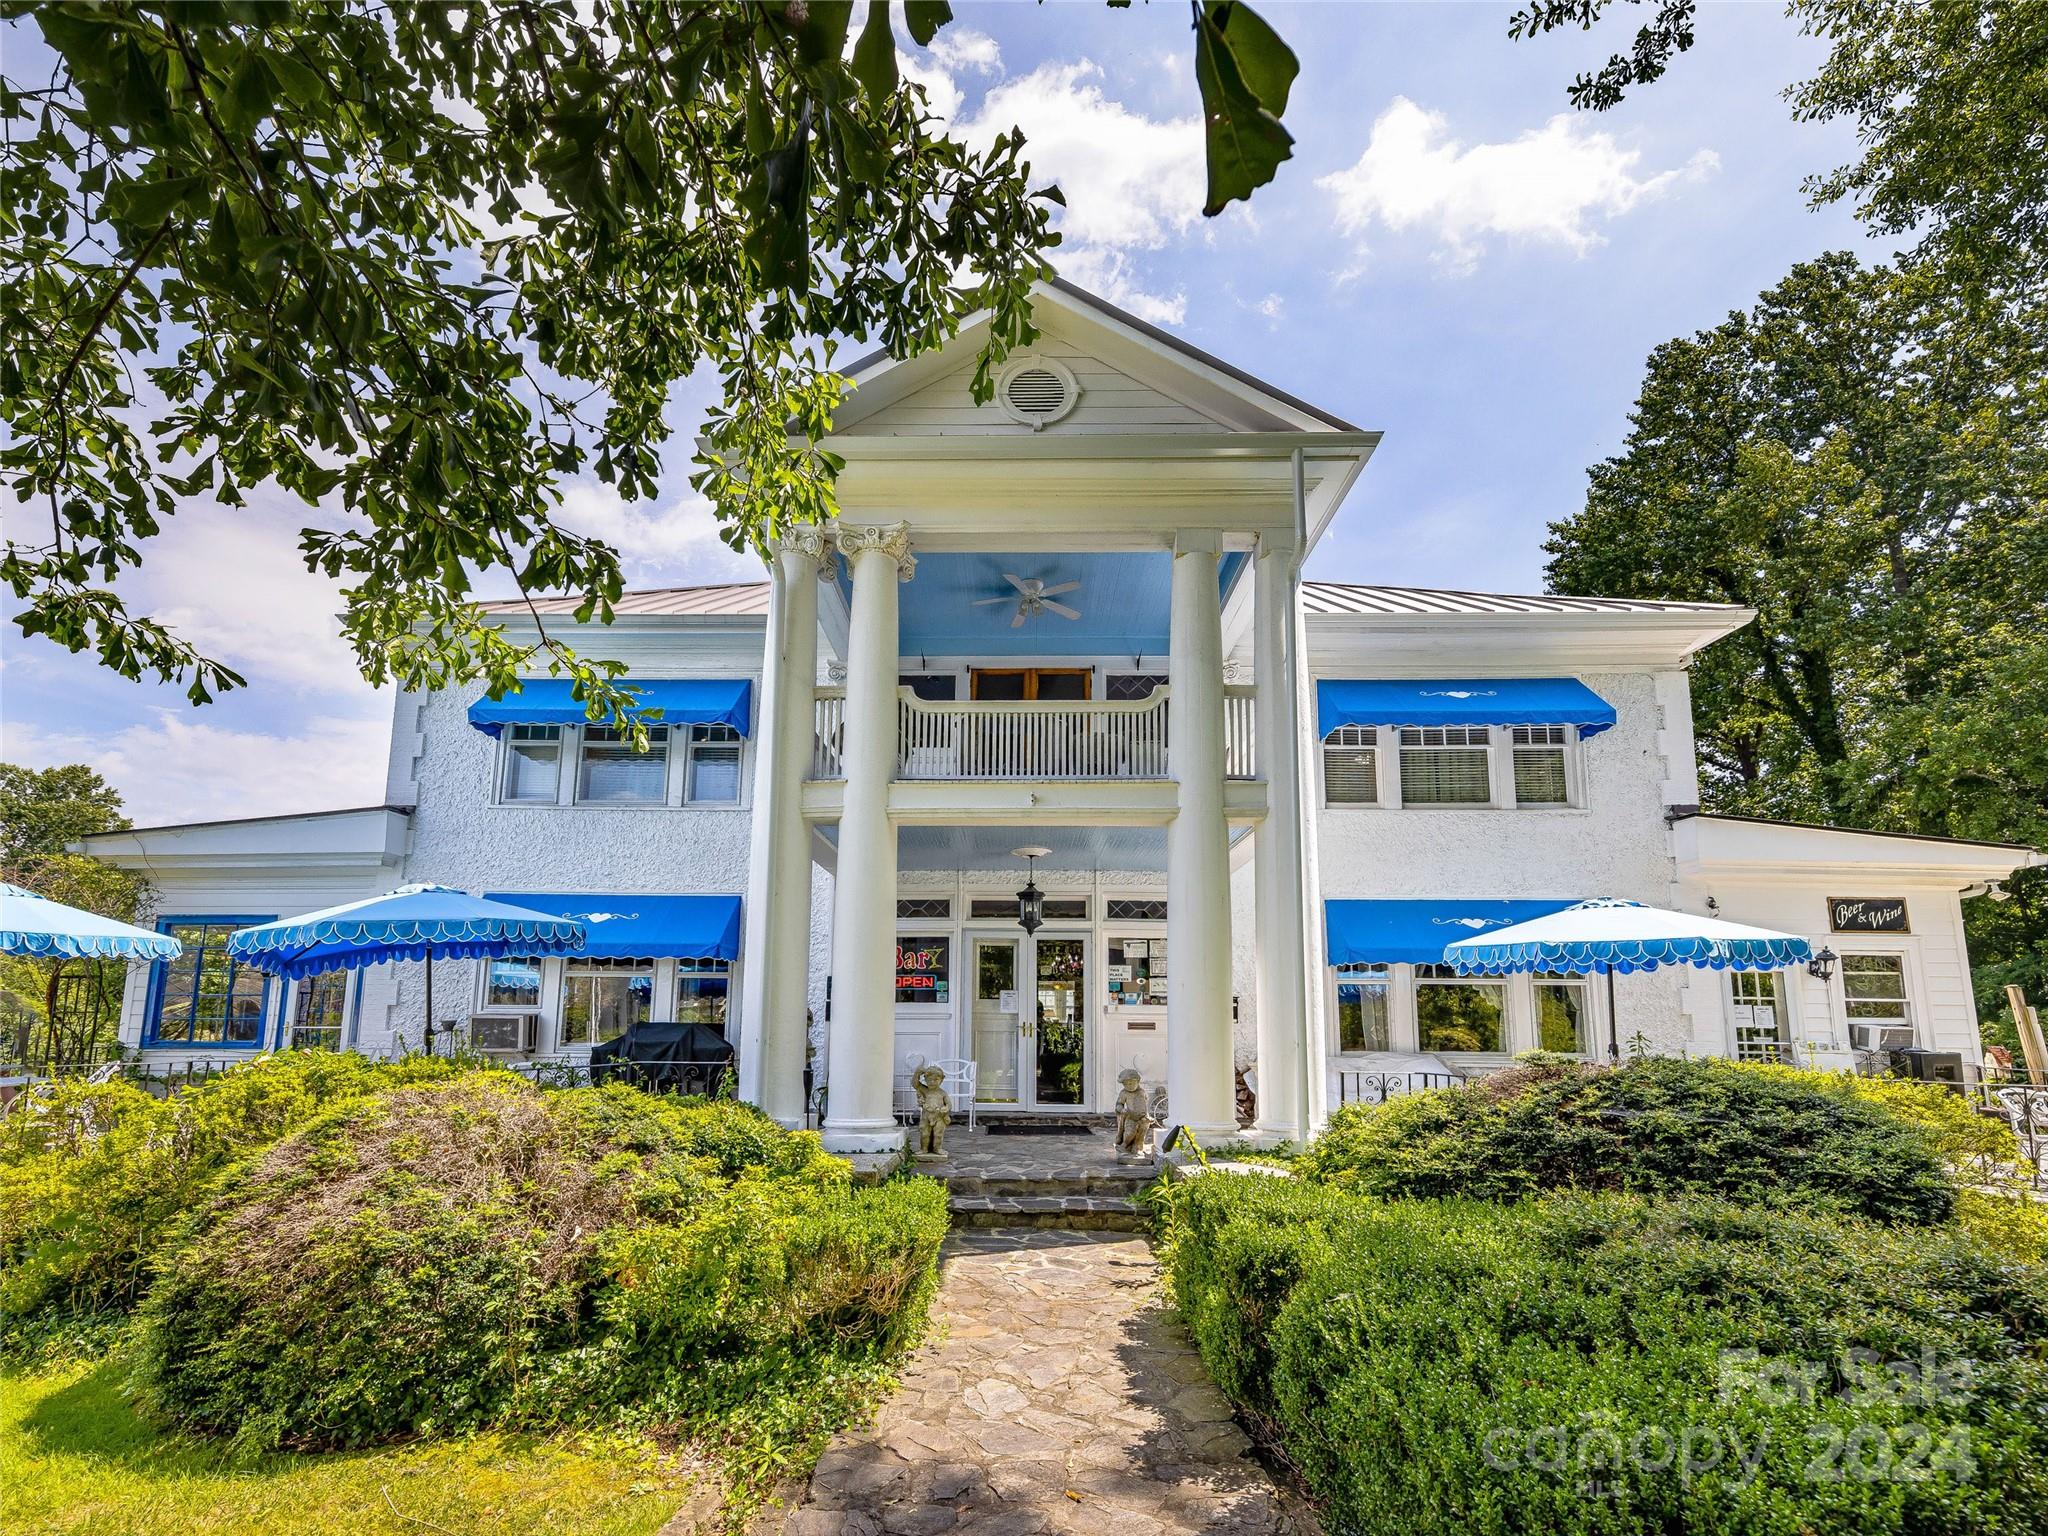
[1546,254,2048,1036]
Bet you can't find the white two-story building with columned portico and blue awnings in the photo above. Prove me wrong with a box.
[86,285,2038,1151]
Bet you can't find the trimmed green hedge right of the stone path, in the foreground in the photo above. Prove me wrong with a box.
[1167,1178,2048,1536]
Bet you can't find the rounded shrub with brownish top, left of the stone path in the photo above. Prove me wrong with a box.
[137,1073,946,1448]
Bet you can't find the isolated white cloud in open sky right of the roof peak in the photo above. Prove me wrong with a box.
[1317,96,1720,272]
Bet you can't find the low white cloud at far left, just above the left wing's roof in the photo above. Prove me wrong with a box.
[0,708,391,827]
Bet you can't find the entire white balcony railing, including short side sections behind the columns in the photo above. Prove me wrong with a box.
[811,684,1257,780]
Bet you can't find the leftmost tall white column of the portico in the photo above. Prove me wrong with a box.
[739,528,825,1126]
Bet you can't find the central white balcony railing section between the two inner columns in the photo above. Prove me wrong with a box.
[897,688,1167,778]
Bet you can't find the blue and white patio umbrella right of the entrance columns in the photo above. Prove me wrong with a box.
[1444,897,1812,1059]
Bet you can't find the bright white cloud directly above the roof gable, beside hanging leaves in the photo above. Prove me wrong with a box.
[958,59,1206,326]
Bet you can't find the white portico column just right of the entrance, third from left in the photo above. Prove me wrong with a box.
[1165,530,1237,1139]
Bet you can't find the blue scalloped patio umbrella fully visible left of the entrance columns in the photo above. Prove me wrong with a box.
[227,885,586,1047]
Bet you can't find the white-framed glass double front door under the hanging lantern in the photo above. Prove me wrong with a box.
[967,936,1087,1110]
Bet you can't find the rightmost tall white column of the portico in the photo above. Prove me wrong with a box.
[1251,539,1309,1141]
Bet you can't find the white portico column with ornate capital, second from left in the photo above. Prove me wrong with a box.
[825,522,915,1153]
